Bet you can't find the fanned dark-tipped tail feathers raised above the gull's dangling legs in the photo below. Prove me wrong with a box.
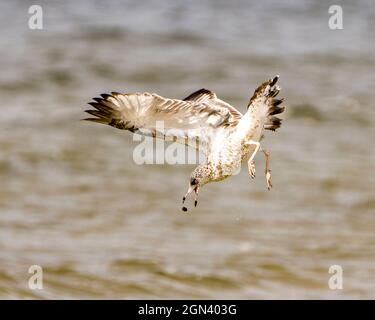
[248,76,285,131]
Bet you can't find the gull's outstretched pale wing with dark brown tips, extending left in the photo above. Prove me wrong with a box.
[84,89,242,150]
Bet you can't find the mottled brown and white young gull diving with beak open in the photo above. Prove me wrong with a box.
[83,76,285,211]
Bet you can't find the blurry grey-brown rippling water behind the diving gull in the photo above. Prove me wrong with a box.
[0,0,375,299]
